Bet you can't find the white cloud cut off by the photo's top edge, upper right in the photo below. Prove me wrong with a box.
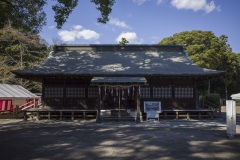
[171,0,220,13]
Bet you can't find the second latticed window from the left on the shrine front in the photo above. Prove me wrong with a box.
[66,87,85,98]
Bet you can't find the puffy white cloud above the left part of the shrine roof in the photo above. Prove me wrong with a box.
[58,25,100,42]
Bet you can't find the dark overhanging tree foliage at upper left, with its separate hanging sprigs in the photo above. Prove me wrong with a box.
[0,0,115,33]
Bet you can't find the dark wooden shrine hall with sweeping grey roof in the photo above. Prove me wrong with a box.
[13,45,224,122]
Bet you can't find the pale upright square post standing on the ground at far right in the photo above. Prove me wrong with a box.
[226,100,236,138]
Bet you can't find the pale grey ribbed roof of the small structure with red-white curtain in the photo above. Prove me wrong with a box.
[0,84,38,99]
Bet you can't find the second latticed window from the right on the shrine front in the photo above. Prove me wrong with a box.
[153,87,172,98]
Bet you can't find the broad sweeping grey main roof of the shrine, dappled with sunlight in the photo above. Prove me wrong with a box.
[13,45,224,77]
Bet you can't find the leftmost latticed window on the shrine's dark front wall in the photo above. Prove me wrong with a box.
[45,87,63,98]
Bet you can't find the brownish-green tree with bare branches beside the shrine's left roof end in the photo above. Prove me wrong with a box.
[0,25,48,90]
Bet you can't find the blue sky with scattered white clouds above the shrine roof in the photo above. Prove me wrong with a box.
[40,0,240,53]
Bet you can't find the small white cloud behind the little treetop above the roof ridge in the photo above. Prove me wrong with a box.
[116,32,143,44]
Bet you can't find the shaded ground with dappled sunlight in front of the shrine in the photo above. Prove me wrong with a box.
[0,119,240,160]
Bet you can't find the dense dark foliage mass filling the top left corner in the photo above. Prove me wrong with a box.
[0,0,47,33]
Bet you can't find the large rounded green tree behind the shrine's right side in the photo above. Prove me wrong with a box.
[159,30,240,98]
